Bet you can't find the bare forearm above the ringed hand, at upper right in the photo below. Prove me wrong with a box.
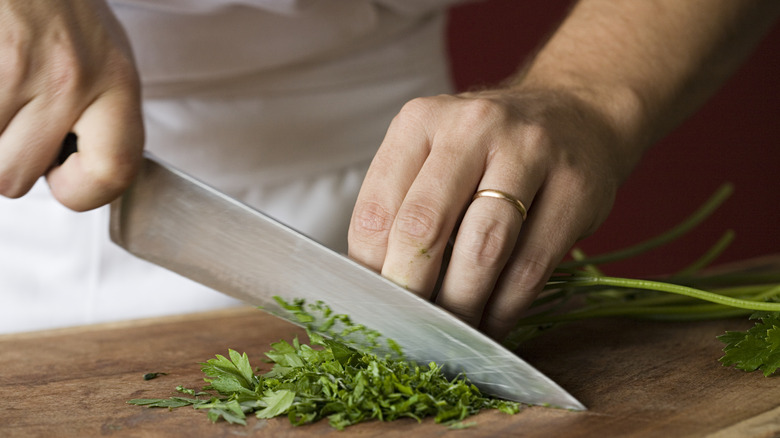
[510,0,780,166]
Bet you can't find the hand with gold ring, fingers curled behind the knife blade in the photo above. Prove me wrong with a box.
[349,90,638,338]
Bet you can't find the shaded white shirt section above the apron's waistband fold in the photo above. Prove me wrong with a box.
[110,0,464,97]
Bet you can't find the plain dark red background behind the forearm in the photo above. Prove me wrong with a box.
[449,0,780,276]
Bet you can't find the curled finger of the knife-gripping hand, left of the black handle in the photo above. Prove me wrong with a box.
[0,97,75,198]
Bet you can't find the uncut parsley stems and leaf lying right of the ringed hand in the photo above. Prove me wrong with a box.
[505,184,780,376]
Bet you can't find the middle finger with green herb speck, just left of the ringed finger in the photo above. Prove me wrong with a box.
[382,130,486,298]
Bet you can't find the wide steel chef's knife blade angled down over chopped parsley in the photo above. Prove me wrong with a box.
[109,154,585,410]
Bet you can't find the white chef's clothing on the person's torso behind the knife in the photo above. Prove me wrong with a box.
[0,0,464,333]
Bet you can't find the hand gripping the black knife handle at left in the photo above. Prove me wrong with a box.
[0,0,144,211]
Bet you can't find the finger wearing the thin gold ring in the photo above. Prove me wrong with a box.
[436,148,543,326]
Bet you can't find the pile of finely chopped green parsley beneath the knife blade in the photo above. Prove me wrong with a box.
[128,297,520,429]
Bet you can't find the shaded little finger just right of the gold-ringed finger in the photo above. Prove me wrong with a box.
[480,178,591,339]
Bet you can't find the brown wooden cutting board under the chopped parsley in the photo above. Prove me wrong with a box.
[0,302,780,438]
